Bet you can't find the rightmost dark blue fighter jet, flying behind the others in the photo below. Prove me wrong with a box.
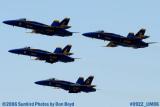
[82,29,155,49]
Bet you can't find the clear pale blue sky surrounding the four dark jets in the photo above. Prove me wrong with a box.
[0,0,160,107]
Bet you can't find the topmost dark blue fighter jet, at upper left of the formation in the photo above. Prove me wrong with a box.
[3,18,73,37]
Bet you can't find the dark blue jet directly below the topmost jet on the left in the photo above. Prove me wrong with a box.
[9,45,75,64]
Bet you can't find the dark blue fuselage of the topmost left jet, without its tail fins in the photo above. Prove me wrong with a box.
[3,19,72,37]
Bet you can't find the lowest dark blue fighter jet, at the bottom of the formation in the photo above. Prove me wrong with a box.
[35,76,96,93]
